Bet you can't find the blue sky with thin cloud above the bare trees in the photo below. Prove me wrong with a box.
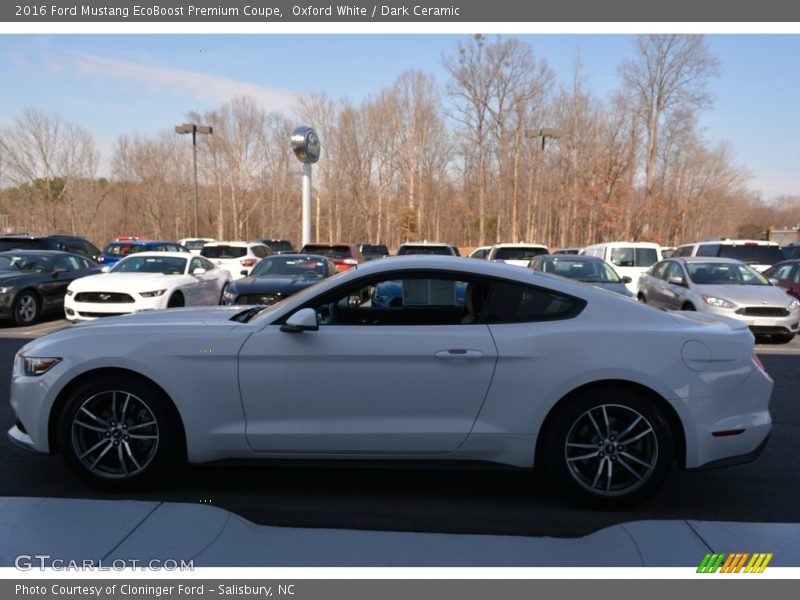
[0,34,800,198]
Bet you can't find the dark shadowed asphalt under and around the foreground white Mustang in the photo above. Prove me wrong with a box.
[0,321,800,537]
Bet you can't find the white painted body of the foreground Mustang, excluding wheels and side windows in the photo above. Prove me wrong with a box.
[9,256,772,504]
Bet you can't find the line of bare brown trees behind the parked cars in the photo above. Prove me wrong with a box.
[0,35,800,248]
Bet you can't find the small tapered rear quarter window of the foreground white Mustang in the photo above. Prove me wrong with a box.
[486,283,586,324]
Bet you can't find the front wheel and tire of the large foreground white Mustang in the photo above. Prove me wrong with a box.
[56,376,178,492]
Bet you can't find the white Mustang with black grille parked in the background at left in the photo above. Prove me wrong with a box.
[64,252,231,321]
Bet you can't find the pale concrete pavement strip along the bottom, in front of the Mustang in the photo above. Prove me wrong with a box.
[0,498,800,570]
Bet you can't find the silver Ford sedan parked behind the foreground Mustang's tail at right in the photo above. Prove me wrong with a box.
[637,256,800,342]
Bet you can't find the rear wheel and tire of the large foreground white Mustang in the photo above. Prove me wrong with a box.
[545,387,674,508]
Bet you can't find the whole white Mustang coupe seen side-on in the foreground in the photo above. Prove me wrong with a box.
[4,256,772,506]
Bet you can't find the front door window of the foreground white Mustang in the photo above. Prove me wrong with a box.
[313,276,472,325]
